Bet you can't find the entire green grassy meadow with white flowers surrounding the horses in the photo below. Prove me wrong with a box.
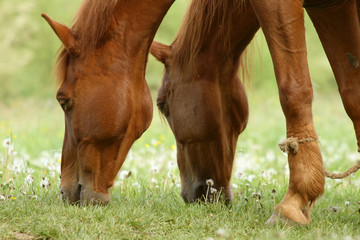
[0,0,360,239]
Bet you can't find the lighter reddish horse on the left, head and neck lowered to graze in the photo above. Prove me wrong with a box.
[42,0,174,204]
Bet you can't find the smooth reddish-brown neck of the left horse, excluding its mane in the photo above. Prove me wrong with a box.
[100,0,174,76]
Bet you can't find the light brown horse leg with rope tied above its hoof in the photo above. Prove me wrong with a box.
[250,0,325,224]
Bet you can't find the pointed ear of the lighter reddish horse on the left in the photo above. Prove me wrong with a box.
[41,13,76,52]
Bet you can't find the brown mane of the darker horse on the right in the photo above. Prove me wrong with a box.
[171,0,244,72]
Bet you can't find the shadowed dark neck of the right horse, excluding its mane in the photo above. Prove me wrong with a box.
[183,2,260,80]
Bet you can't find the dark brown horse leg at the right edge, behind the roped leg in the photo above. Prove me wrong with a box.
[304,0,360,151]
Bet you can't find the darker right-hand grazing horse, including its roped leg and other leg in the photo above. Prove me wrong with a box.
[150,0,360,224]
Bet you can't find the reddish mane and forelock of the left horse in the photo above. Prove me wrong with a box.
[56,0,121,85]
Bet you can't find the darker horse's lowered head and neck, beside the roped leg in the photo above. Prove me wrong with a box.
[150,0,259,202]
